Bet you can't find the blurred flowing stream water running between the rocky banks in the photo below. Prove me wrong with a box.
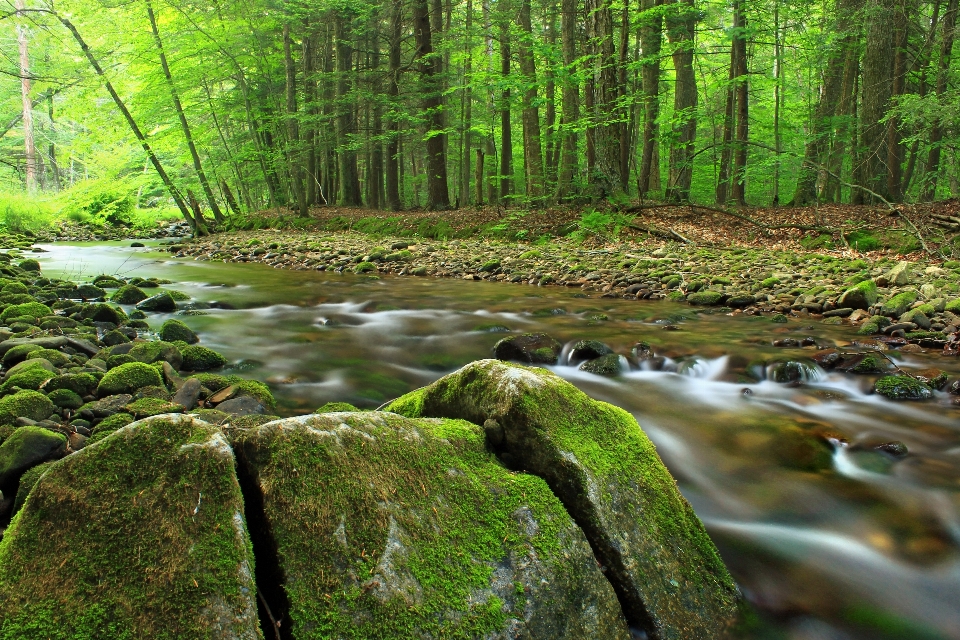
[38,243,960,639]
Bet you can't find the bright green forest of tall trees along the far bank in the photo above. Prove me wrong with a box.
[0,0,960,231]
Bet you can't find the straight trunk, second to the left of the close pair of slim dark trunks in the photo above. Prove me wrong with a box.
[640,0,663,197]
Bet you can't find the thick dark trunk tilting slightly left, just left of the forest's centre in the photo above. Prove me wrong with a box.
[413,0,450,211]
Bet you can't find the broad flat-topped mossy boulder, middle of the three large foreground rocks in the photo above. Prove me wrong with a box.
[235,413,630,640]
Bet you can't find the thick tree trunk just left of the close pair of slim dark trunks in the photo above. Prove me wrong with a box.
[666,0,698,202]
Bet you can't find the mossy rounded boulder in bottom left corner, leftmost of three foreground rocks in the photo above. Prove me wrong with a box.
[0,416,262,640]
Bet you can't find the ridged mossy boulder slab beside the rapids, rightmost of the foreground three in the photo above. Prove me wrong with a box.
[387,360,740,640]
